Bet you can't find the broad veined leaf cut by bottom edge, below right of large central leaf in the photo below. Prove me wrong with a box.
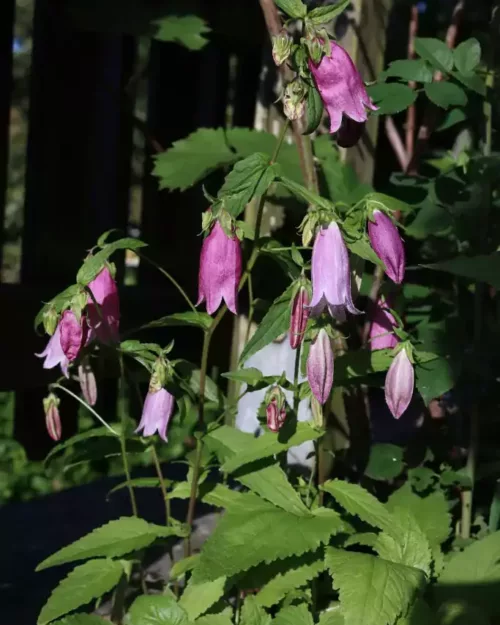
[325,547,425,625]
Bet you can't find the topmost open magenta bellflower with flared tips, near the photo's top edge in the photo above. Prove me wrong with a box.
[309,41,377,133]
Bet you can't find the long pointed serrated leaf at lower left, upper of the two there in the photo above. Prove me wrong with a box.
[36,517,187,571]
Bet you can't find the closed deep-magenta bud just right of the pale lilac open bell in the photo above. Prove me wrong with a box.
[368,210,406,284]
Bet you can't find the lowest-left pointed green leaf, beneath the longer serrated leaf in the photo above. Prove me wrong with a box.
[37,558,123,625]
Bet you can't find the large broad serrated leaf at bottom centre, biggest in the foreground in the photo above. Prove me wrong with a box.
[193,493,344,582]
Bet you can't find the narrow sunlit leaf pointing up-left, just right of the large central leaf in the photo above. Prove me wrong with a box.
[323,480,394,531]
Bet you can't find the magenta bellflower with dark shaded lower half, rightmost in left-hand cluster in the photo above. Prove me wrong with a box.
[87,267,120,343]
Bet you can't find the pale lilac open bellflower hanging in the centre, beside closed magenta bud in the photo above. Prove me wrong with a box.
[311,221,360,321]
